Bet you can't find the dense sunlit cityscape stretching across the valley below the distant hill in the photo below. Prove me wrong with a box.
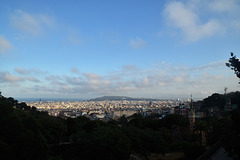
[27,99,193,120]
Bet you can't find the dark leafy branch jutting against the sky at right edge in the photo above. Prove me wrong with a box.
[226,52,240,83]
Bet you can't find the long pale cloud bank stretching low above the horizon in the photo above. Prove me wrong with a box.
[0,61,238,98]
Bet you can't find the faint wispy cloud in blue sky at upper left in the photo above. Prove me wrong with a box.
[10,10,54,36]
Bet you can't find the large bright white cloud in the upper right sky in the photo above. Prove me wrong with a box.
[164,1,224,42]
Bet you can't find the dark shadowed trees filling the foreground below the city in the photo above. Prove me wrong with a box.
[0,92,240,160]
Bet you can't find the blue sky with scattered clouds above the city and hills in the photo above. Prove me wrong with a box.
[0,0,240,99]
